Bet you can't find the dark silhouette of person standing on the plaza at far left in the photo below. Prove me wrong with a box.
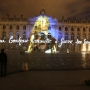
[0,49,7,76]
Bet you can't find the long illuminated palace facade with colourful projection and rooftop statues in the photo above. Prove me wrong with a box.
[0,9,90,52]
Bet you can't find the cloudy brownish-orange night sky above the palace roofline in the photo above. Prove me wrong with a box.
[0,0,90,19]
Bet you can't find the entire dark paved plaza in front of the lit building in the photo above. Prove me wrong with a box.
[0,52,90,90]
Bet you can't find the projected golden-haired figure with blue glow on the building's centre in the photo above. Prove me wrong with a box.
[28,15,58,52]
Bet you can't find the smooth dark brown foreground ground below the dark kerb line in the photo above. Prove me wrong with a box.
[0,70,90,90]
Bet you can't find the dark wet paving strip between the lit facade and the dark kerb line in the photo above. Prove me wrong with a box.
[8,53,90,72]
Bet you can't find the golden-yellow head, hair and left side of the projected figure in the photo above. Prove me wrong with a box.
[28,16,49,52]
